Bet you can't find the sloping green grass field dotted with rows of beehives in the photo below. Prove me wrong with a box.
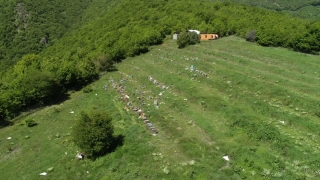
[0,37,320,180]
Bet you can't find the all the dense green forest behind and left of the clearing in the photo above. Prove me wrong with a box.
[0,0,320,121]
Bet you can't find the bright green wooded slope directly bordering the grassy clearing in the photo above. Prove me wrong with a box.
[0,0,320,122]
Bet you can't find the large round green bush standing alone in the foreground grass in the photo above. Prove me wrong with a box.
[73,111,115,158]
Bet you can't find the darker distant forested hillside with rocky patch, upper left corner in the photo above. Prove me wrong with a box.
[0,0,95,70]
